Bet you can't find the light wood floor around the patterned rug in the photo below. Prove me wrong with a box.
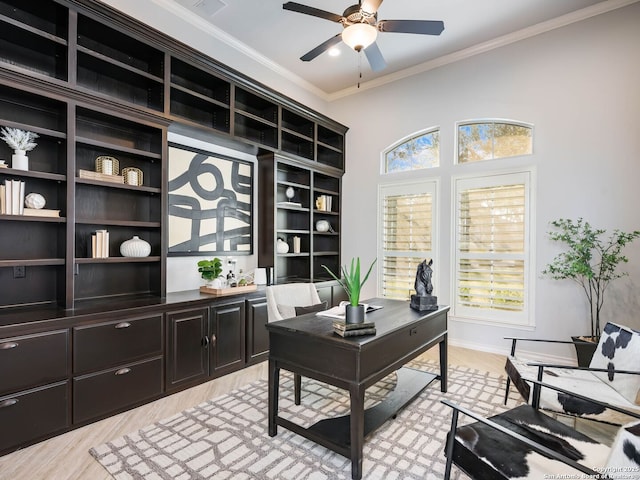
[0,346,505,480]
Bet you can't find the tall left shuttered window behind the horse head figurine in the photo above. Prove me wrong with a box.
[378,181,436,300]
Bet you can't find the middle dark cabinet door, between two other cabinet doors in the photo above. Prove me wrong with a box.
[210,300,245,376]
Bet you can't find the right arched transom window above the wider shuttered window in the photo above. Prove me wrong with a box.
[458,121,533,163]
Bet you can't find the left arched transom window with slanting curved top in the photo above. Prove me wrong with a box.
[384,129,440,173]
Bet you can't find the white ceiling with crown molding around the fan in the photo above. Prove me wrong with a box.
[165,0,637,97]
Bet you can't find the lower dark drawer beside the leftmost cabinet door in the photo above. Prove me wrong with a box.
[73,357,163,423]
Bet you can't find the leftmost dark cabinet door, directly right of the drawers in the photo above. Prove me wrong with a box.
[166,308,209,389]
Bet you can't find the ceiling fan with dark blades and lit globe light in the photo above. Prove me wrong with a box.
[282,0,444,72]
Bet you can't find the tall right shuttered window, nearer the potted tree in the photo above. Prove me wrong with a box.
[454,171,532,325]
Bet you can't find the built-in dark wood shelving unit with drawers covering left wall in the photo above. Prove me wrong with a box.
[0,0,347,454]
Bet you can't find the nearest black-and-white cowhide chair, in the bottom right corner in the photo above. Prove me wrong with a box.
[442,380,640,480]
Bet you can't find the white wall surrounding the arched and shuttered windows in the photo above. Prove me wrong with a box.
[329,4,640,356]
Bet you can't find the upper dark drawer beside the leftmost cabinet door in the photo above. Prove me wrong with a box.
[73,314,162,375]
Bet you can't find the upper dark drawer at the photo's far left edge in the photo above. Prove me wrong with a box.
[0,330,69,395]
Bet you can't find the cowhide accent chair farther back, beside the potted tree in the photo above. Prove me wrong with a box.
[505,323,640,425]
